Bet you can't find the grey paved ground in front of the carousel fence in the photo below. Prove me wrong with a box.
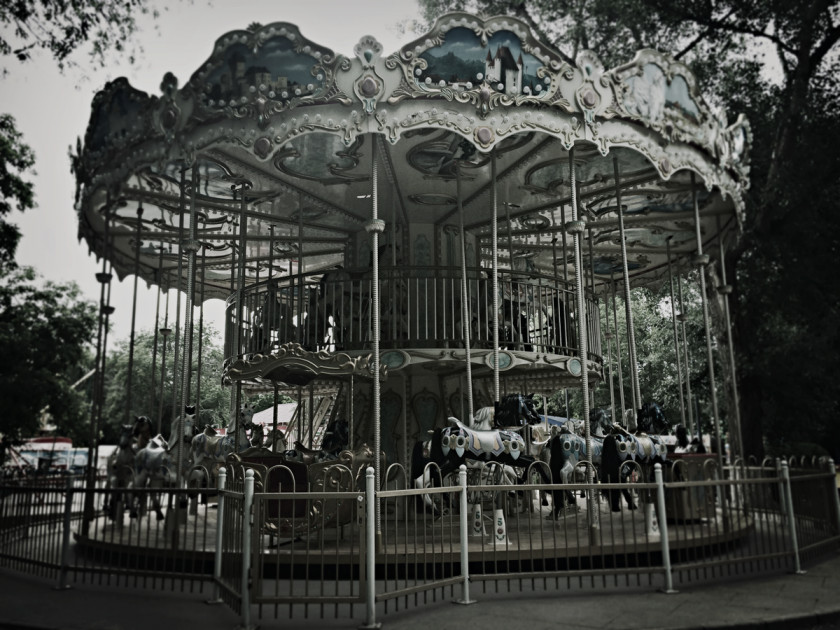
[0,554,840,630]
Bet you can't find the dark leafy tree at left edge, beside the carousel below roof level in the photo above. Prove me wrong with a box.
[0,267,97,456]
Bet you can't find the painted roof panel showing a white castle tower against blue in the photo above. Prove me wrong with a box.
[415,27,547,96]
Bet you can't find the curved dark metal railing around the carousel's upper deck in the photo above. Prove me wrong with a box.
[225,267,601,359]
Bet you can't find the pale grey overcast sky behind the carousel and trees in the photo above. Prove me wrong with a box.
[0,0,419,347]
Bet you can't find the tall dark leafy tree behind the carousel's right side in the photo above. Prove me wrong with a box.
[421,0,840,457]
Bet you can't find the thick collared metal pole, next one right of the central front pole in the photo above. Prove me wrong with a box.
[564,146,598,545]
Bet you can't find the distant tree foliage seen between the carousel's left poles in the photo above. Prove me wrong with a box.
[100,327,231,443]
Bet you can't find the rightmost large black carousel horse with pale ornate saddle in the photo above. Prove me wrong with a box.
[601,402,668,512]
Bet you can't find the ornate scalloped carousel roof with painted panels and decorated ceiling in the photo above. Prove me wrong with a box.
[76,13,750,299]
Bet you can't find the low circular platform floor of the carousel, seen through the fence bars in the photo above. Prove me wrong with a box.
[75,492,762,577]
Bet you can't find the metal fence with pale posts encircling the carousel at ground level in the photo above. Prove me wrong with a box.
[0,458,840,626]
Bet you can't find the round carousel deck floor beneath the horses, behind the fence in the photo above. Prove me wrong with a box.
[77,498,754,570]
